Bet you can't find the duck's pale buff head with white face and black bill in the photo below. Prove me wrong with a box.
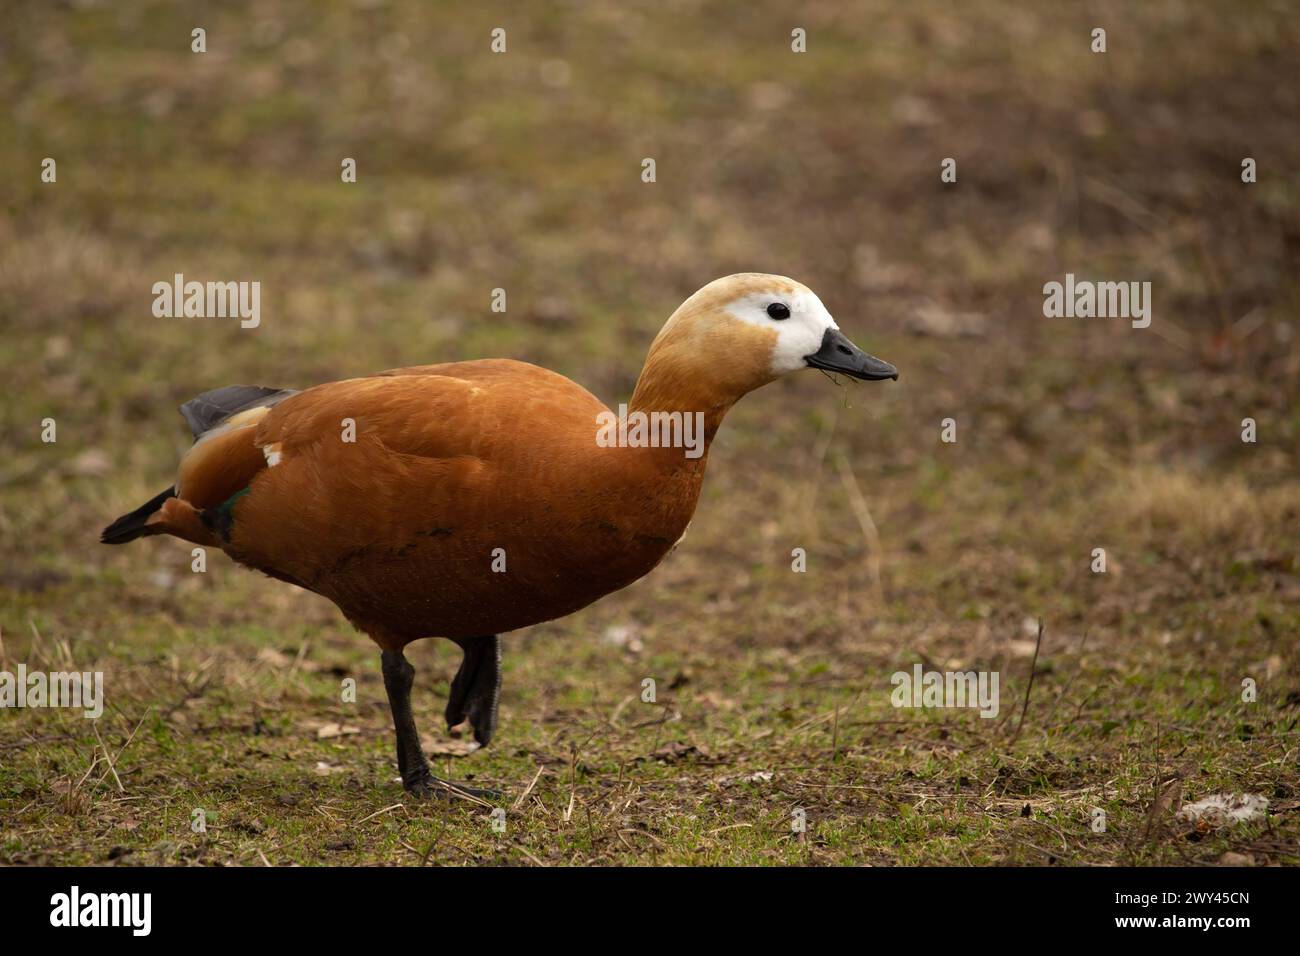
[637,272,898,405]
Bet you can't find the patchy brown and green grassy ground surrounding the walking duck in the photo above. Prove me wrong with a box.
[0,1,1300,865]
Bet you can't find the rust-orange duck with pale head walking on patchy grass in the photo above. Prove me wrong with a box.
[100,273,898,797]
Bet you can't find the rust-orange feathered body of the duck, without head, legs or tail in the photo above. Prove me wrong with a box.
[175,360,706,649]
